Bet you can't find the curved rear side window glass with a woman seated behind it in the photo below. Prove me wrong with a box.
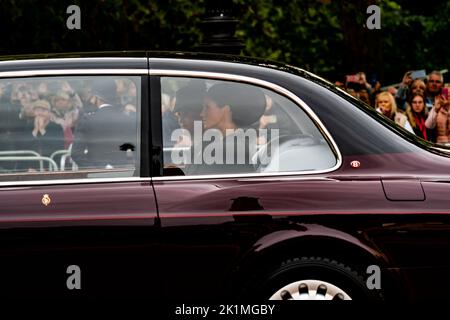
[161,77,337,176]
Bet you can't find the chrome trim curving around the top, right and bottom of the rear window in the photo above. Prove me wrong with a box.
[150,67,342,181]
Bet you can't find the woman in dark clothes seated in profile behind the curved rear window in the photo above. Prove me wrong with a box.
[186,82,266,175]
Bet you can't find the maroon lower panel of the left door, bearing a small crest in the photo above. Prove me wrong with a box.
[0,181,157,299]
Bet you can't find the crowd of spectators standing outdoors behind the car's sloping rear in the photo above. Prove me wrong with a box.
[336,71,450,144]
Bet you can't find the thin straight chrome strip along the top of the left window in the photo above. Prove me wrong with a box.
[0,69,148,78]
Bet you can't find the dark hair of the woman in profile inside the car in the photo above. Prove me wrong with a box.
[206,82,266,127]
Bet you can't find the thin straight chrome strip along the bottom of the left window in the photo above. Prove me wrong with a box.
[0,177,152,191]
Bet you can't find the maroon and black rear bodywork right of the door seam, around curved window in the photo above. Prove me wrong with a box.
[150,54,450,298]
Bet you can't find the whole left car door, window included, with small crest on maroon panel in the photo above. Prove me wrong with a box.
[0,70,160,301]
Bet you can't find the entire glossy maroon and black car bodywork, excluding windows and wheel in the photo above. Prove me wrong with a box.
[0,53,450,300]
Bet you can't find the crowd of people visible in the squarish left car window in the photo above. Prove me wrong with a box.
[0,78,137,172]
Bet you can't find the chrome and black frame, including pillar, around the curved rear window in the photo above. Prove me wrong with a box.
[149,68,343,181]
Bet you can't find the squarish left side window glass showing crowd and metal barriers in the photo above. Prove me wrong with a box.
[0,76,140,181]
